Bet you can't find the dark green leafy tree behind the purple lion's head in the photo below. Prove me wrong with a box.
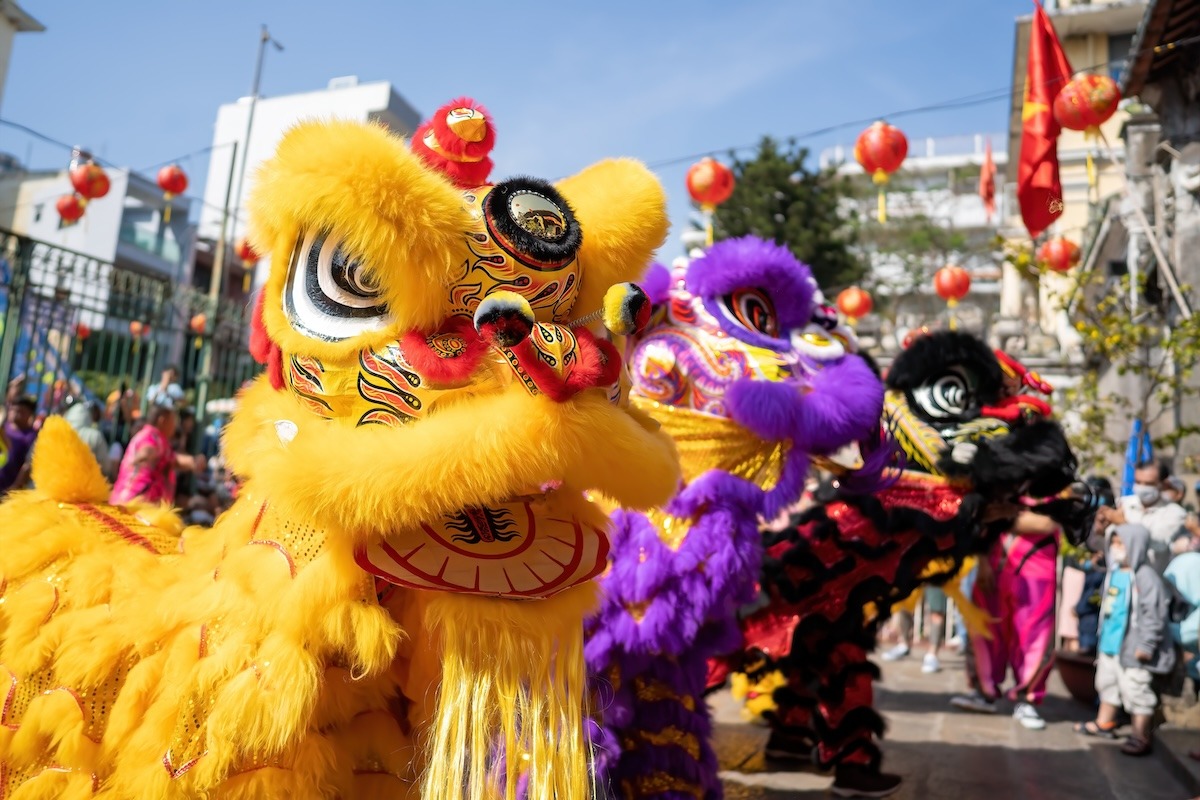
[713,137,866,290]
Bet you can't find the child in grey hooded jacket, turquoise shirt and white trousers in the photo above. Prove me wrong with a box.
[1075,523,1175,756]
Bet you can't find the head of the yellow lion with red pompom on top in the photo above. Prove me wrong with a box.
[227,100,678,599]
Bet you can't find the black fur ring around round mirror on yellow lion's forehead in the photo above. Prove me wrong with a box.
[484,178,583,269]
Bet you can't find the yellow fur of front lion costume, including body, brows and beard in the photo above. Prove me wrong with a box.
[0,113,678,800]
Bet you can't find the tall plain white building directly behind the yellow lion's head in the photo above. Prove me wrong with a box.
[199,77,421,286]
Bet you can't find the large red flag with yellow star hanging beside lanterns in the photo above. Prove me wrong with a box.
[1016,2,1072,239]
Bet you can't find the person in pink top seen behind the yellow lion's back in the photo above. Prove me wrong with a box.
[109,405,204,504]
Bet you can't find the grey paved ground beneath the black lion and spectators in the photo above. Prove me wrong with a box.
[714,657,1200,800]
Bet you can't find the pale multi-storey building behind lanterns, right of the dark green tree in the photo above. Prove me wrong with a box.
[820,133,1008,350]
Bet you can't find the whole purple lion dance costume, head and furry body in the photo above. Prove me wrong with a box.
[586,236,888,800]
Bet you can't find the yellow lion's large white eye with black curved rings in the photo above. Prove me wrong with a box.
[283,233,389,342]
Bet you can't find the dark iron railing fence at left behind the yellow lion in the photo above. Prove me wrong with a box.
[0,225,258,433]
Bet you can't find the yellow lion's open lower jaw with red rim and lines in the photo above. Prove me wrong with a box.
[355,482,608,600]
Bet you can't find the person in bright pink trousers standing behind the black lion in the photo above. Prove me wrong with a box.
[950,511,1058,730]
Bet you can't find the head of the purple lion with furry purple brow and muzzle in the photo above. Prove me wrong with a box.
[629,236,884,513]
